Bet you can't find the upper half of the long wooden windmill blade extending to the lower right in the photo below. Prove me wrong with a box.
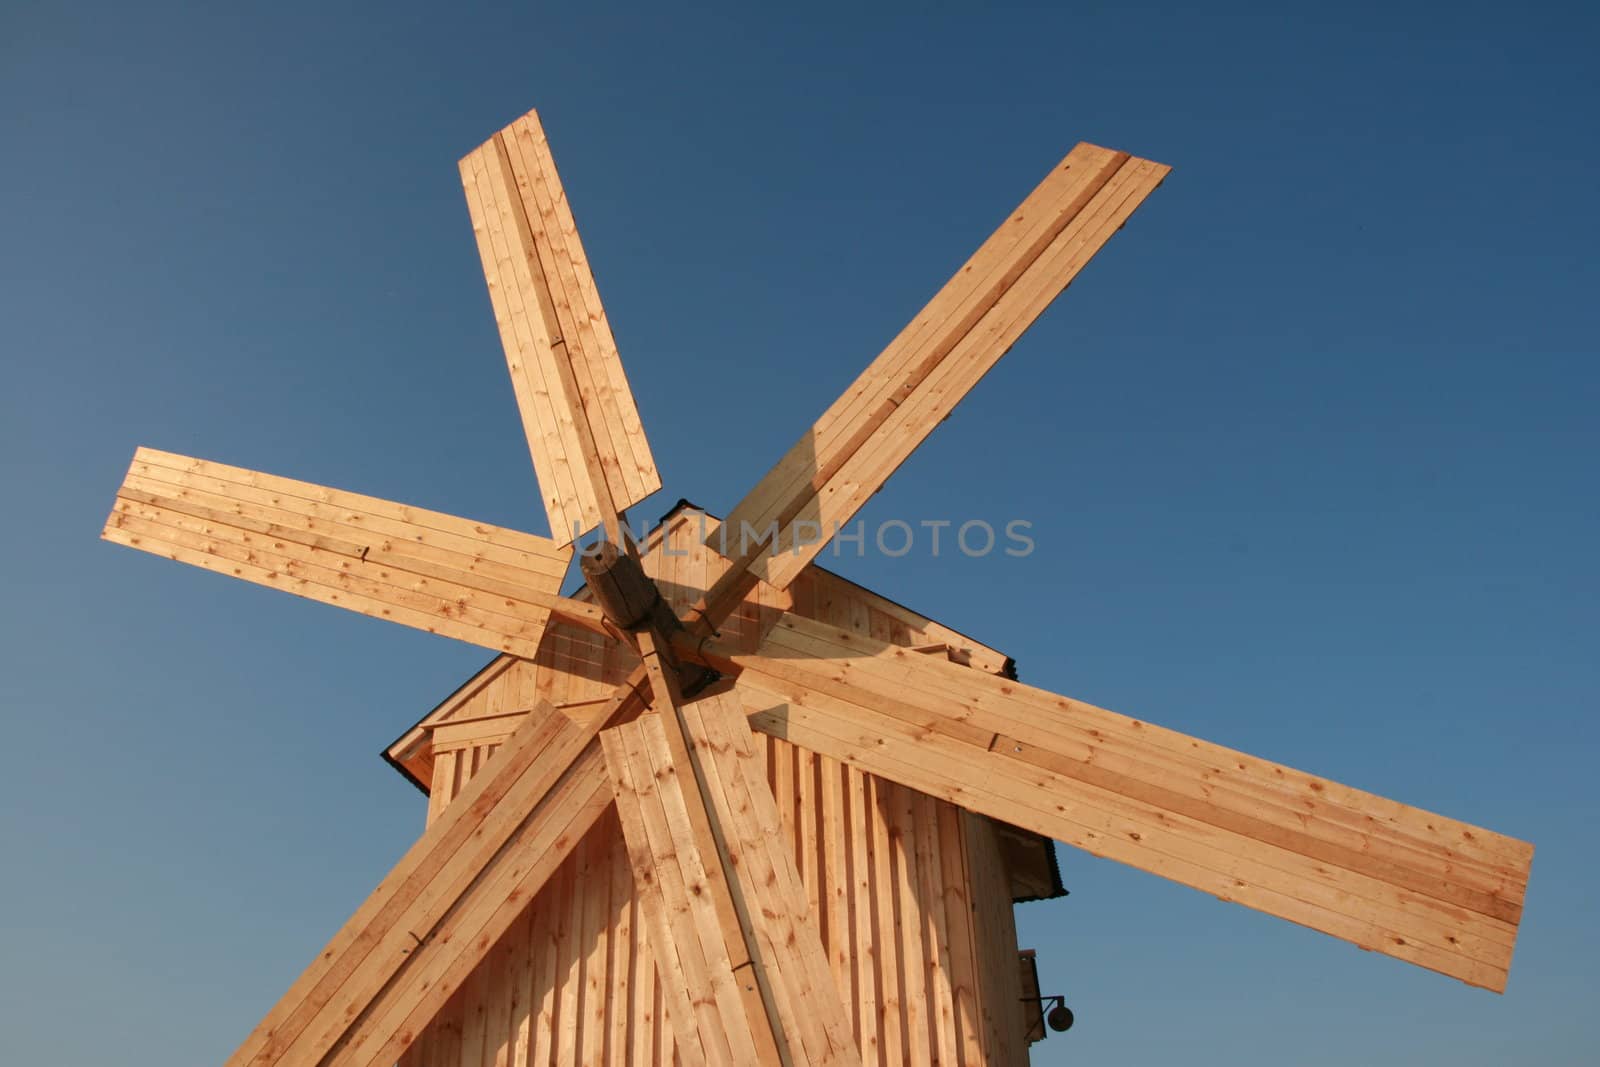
[755,625,1531,921]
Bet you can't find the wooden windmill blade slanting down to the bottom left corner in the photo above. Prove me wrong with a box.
[226,684,645,1067]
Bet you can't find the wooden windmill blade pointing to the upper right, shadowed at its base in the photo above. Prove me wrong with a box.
[707,144,1171,603]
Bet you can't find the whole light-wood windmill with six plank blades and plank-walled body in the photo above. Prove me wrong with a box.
[104,114,1533,1067]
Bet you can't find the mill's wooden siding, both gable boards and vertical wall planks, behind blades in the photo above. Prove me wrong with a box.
[389,510,1027,1067]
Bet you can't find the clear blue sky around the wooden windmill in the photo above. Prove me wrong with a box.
[0,3,1600,1067]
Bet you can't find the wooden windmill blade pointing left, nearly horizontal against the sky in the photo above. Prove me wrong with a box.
[101,448,605,659]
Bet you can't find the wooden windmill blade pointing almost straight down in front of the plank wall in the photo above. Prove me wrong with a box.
[600,688,861,1067]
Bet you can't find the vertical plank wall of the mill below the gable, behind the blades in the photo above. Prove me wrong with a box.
[402,737,1027,1067]
